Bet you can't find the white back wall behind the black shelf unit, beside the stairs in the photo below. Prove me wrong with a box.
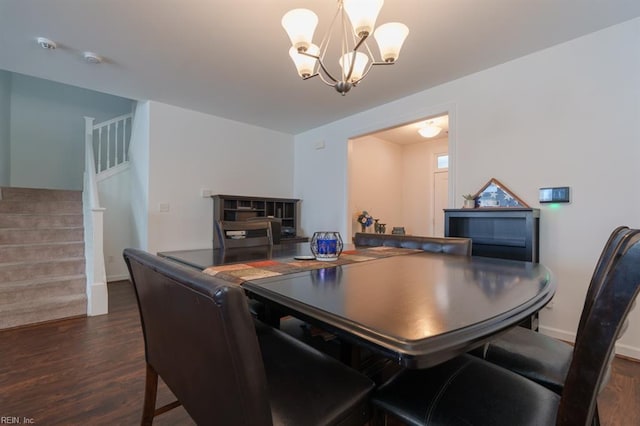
[146,102,294,252]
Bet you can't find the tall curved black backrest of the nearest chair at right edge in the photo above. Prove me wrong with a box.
[556,230,640,425]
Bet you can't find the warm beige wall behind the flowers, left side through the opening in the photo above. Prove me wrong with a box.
[348,136,403,235]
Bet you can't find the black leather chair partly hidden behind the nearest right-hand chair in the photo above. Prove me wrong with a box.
[471,226,635,394]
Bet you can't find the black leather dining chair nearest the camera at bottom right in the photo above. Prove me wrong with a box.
[372,232,640,426]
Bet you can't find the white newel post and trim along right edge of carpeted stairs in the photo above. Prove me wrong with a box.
[82,117,109,315]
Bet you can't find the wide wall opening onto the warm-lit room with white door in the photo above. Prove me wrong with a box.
[348,114,449,236]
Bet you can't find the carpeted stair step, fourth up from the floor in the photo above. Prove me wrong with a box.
[0,242,84,265]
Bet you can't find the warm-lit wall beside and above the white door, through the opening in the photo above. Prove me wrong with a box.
[402,138,448,235]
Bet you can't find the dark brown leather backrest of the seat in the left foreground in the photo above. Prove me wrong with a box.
[124,249,272,425]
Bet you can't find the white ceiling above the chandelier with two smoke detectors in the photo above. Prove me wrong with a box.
[0,0,640,134]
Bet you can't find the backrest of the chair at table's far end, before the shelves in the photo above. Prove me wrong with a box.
[214,220,273,250]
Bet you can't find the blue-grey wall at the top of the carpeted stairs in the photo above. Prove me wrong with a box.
[10,73,132,190]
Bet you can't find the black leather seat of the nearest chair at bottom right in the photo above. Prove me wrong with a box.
[372,355,560,426]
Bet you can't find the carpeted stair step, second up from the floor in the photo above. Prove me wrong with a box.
[0,275,87,304]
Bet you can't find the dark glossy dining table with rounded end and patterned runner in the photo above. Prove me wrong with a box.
[158,243,556,368]
